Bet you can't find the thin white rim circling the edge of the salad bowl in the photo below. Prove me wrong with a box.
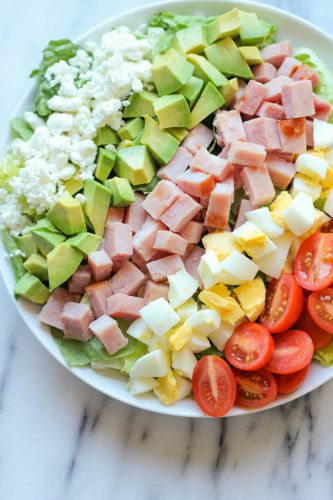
[0,0,333,418]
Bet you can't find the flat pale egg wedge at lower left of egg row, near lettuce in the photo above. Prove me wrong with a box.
[130,349,171,377]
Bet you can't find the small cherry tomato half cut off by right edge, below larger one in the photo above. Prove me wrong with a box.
[308,288,333,334]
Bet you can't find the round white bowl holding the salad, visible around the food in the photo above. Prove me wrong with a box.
[0,0,333,417]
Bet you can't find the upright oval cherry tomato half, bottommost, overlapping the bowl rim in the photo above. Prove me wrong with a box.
[192,355,237,417]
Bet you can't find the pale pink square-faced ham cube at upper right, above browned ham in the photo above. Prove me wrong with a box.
[281,80,315,119]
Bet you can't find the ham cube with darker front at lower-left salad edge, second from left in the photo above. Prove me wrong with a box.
[60,302,94,340]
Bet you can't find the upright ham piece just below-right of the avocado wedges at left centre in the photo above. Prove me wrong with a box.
[104,222,133,261]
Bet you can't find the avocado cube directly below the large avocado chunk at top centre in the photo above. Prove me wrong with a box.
[154,94,190,128]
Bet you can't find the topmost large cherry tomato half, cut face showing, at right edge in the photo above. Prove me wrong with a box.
[294,233,333,291]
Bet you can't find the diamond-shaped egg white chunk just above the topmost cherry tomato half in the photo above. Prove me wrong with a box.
[283,193,316,236]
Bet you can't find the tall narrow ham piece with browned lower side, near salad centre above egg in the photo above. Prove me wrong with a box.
[205,176,234,229]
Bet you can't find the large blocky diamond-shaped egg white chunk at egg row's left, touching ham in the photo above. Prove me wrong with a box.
[140,297,180,337]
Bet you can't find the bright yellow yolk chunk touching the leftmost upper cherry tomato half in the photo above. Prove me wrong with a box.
[234,278,269,321]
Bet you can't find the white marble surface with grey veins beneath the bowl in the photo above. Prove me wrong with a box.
[0,0,333,500]
